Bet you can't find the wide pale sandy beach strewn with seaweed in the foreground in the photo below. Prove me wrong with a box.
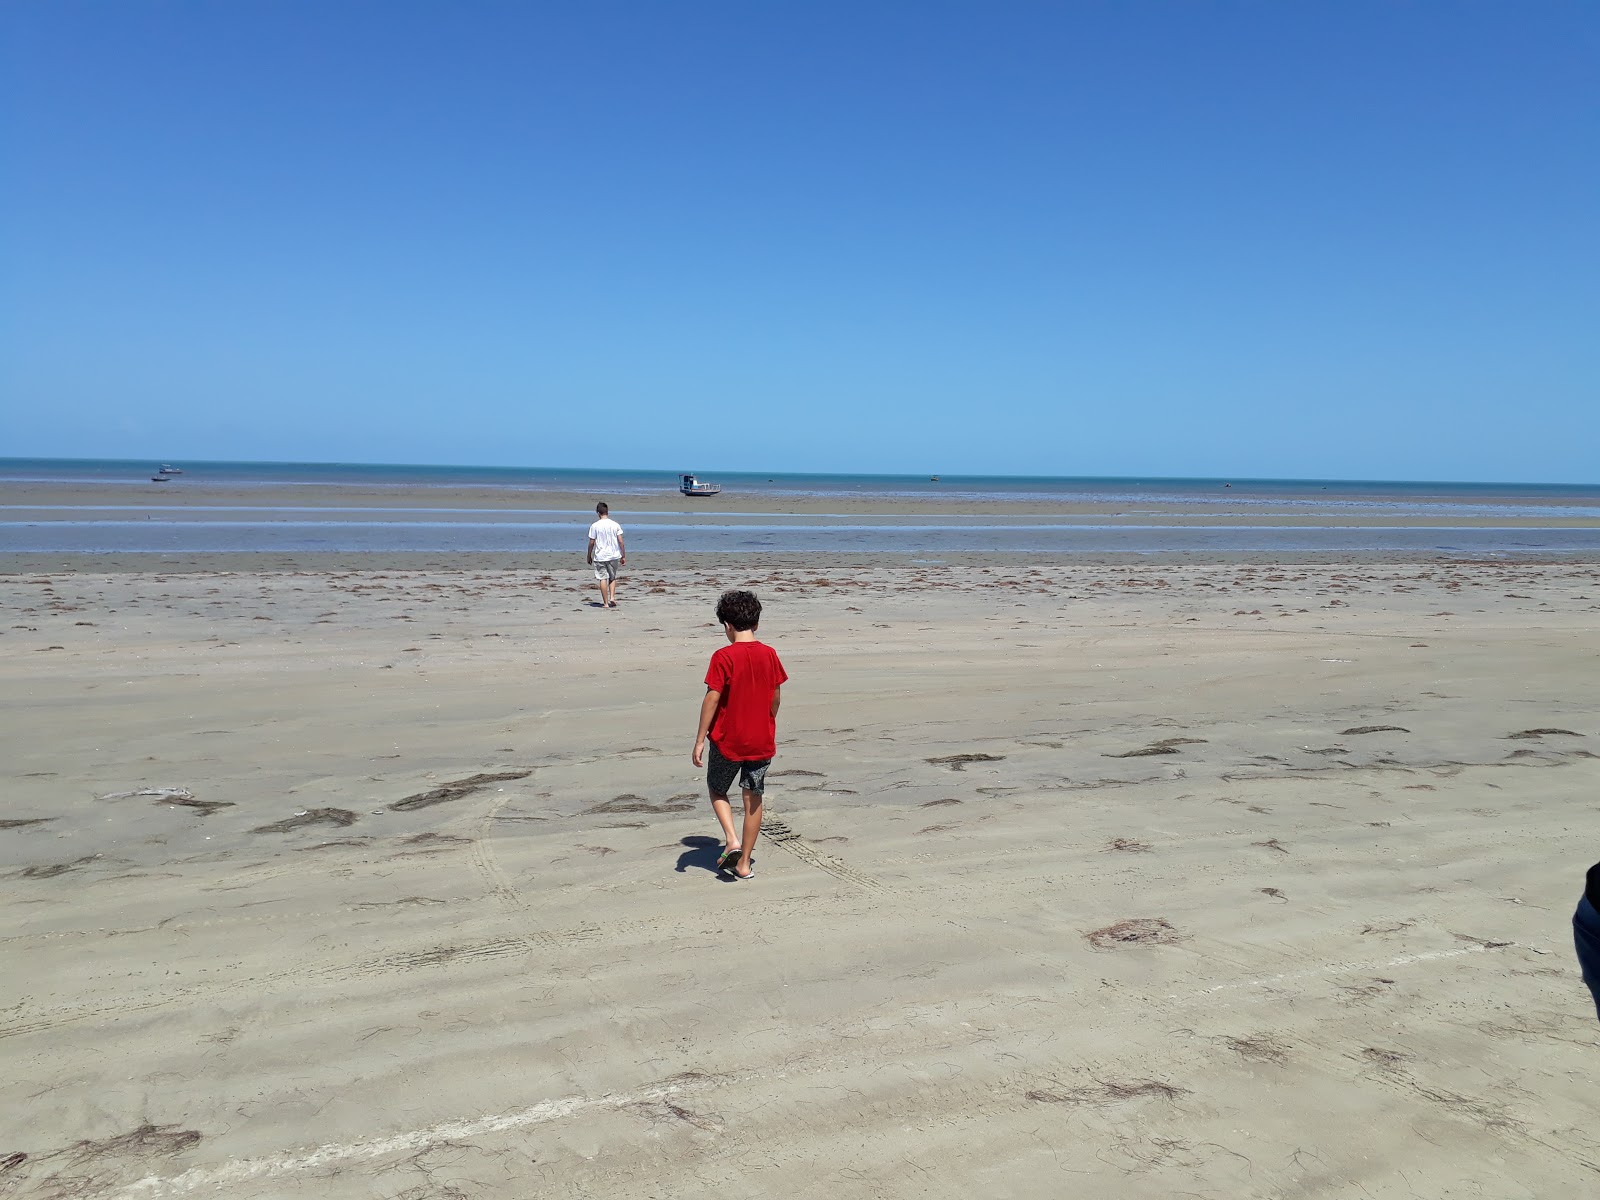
[0,560,1600,1200]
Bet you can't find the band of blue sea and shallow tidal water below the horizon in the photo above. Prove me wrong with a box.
[0,459,1600,557]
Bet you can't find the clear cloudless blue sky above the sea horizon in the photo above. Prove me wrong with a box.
[0,0,1600,482]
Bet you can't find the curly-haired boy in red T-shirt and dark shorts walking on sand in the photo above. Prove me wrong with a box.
[690,592,789,878]
